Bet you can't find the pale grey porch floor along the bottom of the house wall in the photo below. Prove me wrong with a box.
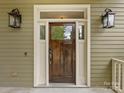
[0,87,114,93]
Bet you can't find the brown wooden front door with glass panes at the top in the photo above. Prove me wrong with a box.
[49,22,75,83]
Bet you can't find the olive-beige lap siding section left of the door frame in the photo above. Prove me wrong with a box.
[0,3,33,87]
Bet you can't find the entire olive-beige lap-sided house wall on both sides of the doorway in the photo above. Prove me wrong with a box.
[0,0,124,87]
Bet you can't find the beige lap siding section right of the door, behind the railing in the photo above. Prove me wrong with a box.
[91,3,124,86]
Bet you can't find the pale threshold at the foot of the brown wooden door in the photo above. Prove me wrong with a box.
[37,83,88,88]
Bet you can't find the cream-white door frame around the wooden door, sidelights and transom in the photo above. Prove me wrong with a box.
[34,4,91,87]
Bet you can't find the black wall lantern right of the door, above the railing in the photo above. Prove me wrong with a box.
[102,8,115,28]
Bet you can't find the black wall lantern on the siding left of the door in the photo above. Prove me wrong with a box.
[8,8,21,28]
